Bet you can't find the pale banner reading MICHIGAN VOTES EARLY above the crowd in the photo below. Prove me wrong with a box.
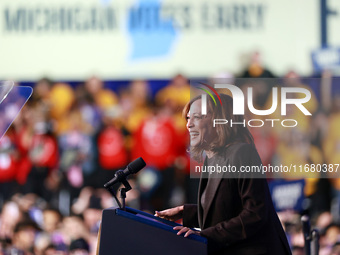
[0,0,326,80]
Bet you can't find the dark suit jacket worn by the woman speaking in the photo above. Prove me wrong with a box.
[183,143,291,255]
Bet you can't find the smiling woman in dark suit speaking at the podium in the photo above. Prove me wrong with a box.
[155,94,291,255]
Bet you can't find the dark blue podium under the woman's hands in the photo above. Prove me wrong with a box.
[99,207,207,255]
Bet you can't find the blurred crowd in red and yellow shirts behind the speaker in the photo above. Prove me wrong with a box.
[0,52,340,255]
